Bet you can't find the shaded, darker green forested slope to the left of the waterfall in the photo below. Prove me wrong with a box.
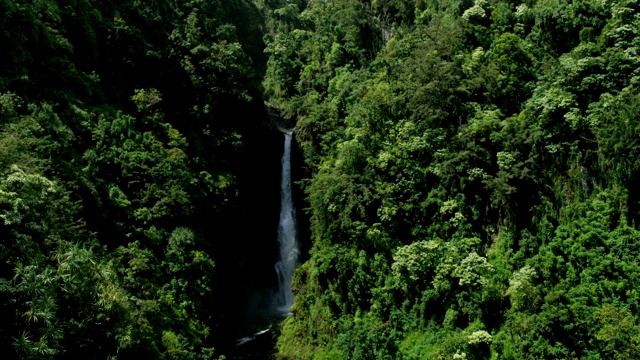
[0,0,277,359]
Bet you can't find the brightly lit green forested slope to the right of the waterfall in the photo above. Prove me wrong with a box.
[264,0,640,360]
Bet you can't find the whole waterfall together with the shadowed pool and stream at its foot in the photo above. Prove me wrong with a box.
[228,129,300,360]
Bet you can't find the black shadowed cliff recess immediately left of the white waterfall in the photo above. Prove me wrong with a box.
[209,109,282,354]
